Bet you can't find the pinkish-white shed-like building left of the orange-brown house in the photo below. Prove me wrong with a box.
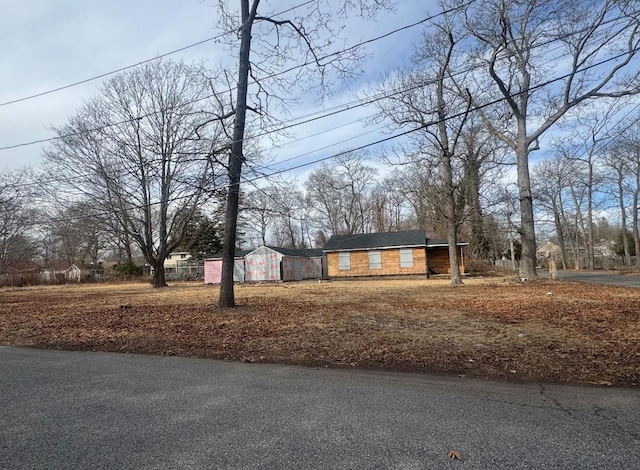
[204,245,323,284]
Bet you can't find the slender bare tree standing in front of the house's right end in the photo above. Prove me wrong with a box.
[372,17,474,285]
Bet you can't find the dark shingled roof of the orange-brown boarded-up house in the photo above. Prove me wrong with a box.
[323,230,427,251]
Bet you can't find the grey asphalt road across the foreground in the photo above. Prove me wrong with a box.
[0,347,640,469]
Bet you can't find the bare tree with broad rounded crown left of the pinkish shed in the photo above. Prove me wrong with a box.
[45,62,228,287]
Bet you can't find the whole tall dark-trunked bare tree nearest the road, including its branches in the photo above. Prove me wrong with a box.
[218,0,387,307]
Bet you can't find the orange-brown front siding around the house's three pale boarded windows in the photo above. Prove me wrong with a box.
[327,247,426,277]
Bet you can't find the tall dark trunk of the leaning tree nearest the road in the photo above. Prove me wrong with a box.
[218,0,258,308]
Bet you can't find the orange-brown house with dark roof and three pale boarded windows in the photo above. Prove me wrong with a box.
[323,230,467,277]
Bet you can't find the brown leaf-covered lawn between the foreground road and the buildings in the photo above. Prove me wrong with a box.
[0,279,640,386]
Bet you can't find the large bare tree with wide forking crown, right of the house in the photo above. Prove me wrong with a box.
[458,0,640,278]
